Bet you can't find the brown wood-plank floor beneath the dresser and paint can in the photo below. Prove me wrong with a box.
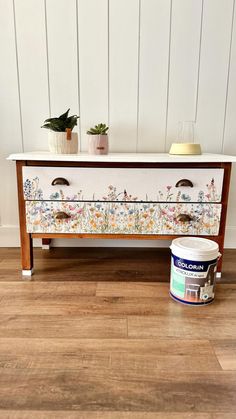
[0,248,236,419]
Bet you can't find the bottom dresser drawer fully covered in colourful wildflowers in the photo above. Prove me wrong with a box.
[26,201,221,235]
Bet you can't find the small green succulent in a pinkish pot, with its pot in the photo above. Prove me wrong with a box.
[87,123,109,154]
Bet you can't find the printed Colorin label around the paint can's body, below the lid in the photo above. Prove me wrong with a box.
[170,254,217,304]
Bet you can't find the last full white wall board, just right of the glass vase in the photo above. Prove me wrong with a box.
[197,0,233,153]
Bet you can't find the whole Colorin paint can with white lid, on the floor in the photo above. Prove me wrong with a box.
[170,237,221,305]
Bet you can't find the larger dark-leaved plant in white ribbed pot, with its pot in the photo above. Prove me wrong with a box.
[41,109,79,154]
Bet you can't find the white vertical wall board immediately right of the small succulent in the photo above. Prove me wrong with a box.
[109,0,139,152]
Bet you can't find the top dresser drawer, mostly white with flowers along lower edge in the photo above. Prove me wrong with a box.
[23,166,224,202]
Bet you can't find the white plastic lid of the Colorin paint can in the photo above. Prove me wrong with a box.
[170,237,220,261]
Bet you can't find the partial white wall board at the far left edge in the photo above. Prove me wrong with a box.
[0,0,22,228]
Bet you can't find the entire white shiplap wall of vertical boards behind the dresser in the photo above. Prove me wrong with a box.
[0,0,236,247]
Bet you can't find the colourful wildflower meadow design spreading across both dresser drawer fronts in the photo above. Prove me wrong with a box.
[24,172,221,235]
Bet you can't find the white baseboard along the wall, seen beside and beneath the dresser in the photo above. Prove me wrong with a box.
[0,225,236,249]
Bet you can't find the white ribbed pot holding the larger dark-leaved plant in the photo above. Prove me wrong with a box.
[48,130,78,154]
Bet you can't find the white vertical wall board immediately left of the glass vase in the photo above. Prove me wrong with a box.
[137,0,171,152]
